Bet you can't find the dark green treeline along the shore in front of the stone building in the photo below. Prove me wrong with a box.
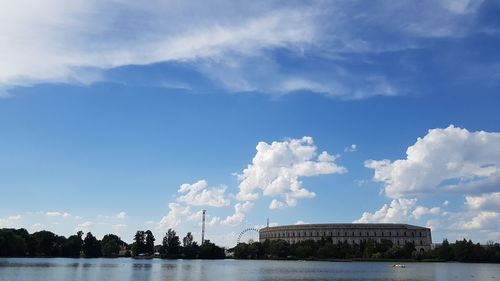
[232,236,500,263]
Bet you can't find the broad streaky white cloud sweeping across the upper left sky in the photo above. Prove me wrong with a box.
[0,0,313,88]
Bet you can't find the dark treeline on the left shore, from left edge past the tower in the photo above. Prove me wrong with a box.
[0,228,225,259]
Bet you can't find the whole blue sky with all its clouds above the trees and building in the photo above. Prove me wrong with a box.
[0,0,500,246]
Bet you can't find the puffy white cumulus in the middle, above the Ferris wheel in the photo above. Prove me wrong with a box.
[236,137,347,207]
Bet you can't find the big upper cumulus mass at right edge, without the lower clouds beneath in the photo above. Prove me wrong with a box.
[365,125,500,198]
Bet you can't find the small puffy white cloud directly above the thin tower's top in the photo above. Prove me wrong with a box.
[177,180,230,207]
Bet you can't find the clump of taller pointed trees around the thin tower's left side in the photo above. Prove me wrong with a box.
[131,229,226,259]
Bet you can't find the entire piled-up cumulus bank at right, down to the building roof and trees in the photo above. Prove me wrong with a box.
[357,126,500,238]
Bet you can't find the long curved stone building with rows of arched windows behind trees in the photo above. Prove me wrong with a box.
[259,223,432,251]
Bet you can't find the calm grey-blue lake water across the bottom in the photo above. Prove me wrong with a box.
[0,258,500,281]
